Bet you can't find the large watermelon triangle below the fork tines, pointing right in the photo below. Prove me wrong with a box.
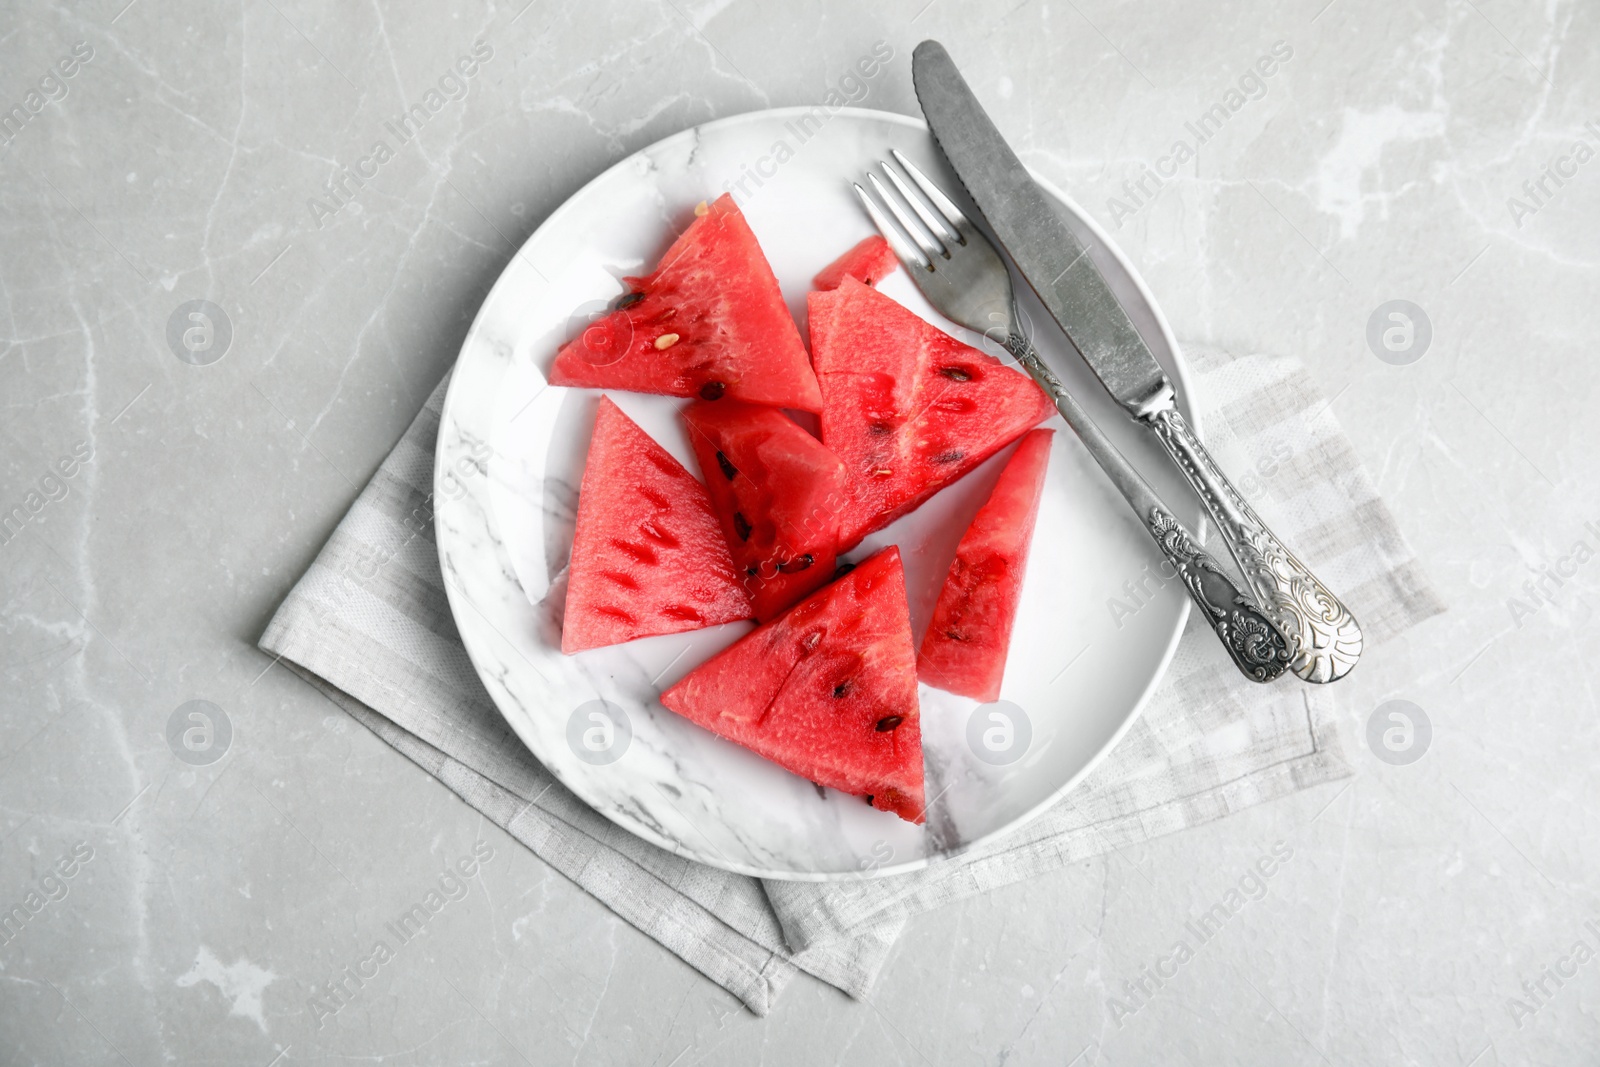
[810,278,1054,552]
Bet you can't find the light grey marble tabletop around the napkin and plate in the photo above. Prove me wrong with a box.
[0,0,1600,1067]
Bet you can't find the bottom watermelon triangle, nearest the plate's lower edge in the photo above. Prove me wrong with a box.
[661,547,923,822]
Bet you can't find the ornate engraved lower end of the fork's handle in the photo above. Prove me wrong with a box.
[1146,507,1293,681]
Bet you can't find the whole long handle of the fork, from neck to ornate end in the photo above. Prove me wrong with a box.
[1005,333,1293,681]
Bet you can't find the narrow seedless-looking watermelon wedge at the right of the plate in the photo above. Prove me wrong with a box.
[917,430,1054,704]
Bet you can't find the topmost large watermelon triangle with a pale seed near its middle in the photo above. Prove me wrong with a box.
[550,195,822,411]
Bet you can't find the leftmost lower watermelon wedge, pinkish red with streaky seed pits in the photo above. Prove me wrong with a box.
[562,397,750,654]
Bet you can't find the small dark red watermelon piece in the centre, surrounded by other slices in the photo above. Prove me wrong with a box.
[683,400,845,621]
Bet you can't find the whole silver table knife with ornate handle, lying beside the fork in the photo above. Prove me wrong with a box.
[912,40,1362,681]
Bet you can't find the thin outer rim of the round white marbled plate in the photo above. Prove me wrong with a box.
[432,106,1206,883]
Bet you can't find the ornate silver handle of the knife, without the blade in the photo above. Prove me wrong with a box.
[1144,406,1363,681]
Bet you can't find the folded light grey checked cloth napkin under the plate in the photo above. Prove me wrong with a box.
[261,347,1443,1014]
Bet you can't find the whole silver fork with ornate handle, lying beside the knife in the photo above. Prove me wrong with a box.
[854,149,1291,681]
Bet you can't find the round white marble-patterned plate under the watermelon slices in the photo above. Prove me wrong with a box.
[435,109,1198,880]
